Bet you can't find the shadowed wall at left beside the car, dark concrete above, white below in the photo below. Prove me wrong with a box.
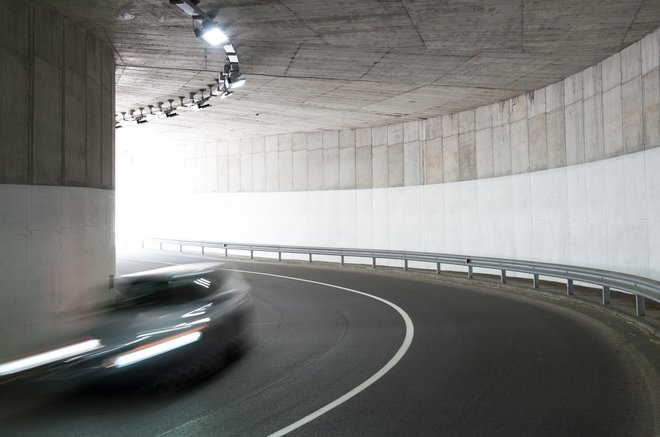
[0,1,115,350]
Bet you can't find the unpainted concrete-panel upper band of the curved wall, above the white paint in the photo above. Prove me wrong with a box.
[147,29,660,192]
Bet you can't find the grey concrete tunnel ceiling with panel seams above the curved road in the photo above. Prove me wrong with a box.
[42,0,660,139]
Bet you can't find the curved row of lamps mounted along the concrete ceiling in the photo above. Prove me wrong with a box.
[115,0,245,128]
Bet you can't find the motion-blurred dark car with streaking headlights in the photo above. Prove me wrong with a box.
[0,263,252,391]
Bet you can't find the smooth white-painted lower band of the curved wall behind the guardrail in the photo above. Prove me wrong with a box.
[117,148,660,279]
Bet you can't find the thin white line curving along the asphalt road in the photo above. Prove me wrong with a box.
[116,252,415,437]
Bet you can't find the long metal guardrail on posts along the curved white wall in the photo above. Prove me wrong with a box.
[142,238,660,316]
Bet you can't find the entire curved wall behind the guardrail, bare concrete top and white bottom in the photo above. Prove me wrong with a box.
[118,30,660,279]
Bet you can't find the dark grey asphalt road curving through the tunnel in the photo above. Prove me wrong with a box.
[0,252,660,436]
